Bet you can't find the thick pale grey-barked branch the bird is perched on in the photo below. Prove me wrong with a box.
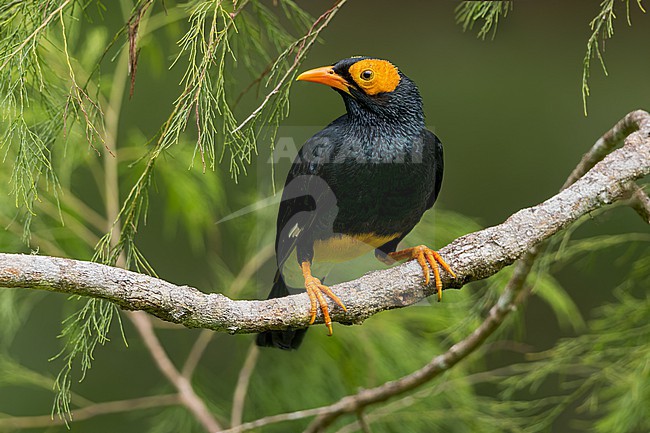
[0,111,650,333]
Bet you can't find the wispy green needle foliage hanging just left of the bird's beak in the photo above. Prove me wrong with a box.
[97,0,338,280]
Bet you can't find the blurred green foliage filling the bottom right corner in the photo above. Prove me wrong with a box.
[492,286,650,433]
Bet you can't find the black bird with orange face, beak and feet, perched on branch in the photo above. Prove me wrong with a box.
[256,56,455,350]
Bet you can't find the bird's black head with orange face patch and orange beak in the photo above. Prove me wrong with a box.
[297,57,424,124]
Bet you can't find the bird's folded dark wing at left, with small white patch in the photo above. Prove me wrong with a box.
[275,118,342,267]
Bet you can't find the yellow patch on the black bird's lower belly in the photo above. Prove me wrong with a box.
[314,233,401,262]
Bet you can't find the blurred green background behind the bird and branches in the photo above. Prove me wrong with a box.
[0,0,650,433]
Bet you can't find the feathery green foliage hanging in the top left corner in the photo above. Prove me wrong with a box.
[0,0,102,241]
